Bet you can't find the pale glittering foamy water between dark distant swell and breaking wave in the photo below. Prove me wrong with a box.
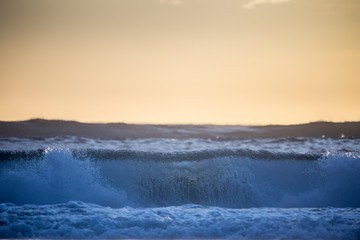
[0,136,360,154]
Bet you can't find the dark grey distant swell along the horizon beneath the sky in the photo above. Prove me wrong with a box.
[0,119,360,140]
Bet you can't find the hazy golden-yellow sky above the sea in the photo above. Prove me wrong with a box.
[0,0,360,125]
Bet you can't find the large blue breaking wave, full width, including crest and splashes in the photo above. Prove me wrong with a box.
[0,148,360,208]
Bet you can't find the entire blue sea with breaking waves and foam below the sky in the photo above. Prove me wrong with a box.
[0,122,360,239]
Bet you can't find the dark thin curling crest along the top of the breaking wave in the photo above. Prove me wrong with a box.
[0,148,322,162]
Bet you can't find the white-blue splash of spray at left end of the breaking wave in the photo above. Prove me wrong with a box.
[0,148,127,206]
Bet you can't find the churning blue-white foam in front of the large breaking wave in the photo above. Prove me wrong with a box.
[0,202,360,239]
